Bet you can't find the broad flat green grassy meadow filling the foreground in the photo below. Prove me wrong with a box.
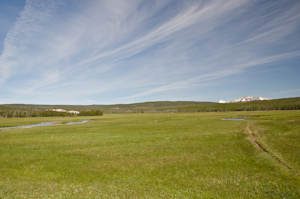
[0,110,300,198]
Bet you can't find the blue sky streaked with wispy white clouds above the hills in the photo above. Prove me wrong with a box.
[0,0,300,105]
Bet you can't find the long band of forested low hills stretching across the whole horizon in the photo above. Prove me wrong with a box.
[0,97,300,118]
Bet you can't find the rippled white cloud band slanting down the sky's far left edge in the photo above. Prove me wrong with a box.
[0,0,60,83]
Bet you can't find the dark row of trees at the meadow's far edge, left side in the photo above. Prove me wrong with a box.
[0,109,103,118]
